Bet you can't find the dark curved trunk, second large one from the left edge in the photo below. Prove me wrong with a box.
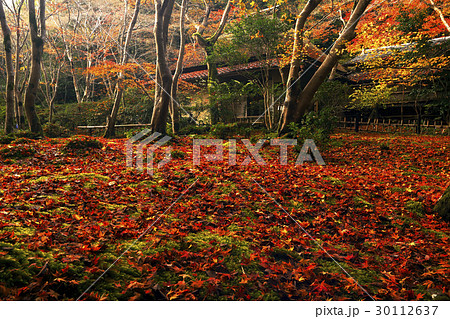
[25,0,45,134]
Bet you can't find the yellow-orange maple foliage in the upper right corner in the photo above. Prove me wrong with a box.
[342,1,450,133]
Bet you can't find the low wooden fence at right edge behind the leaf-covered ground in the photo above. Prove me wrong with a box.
[338,118,450,135]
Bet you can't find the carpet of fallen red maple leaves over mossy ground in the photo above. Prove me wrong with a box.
[0,133,450,300]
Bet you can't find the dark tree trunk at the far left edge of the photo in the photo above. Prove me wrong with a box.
[0,1,14,134]
